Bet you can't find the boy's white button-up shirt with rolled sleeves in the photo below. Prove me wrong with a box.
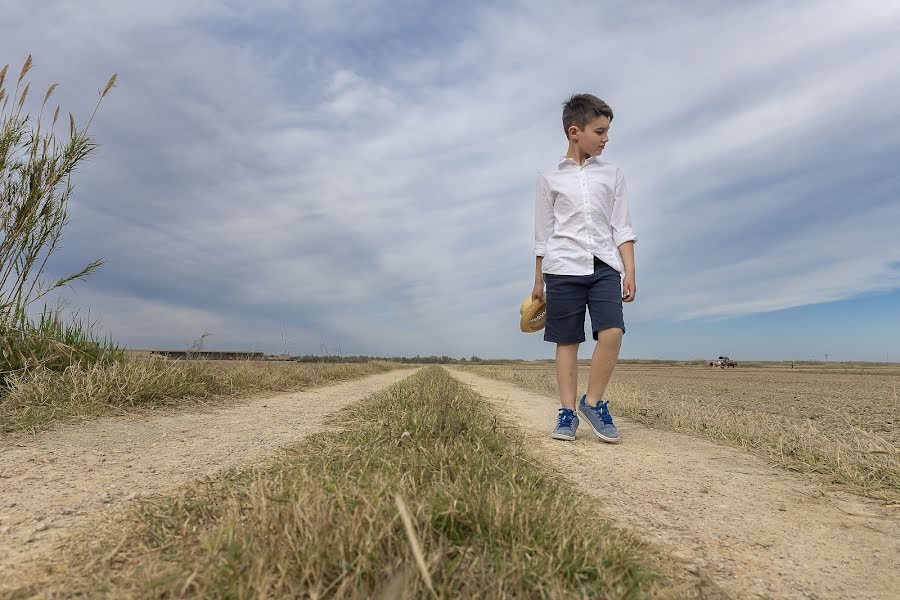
[534,157,637,275]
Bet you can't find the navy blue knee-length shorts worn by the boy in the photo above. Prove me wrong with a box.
[544,257,625,344]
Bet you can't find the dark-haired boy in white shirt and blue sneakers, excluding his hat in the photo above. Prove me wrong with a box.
[531,94,637,443]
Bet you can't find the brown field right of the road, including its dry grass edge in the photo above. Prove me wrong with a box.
[463,363,900,503]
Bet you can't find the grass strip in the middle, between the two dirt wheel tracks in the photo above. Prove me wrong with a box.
[22,367,690,598]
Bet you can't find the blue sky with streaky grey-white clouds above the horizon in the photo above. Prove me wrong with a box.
[0,0,900,361]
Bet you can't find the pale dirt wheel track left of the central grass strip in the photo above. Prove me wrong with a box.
[0,369,416,587]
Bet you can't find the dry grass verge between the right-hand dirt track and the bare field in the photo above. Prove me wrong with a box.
[465,366,900,501]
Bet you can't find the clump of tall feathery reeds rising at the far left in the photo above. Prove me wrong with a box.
[0,55,115,384]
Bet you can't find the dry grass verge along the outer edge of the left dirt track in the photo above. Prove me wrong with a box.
[0,358,400,433]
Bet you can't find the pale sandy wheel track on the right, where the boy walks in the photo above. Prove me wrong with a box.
[450,369,900,600]
